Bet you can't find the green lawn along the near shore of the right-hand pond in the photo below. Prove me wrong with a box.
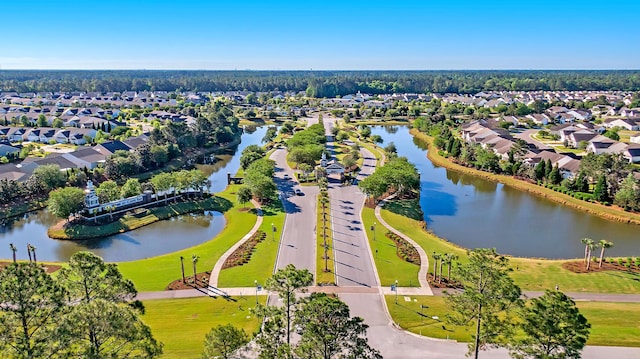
[380,209,640,293]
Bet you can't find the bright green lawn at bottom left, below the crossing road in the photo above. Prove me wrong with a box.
[142,293,266,358]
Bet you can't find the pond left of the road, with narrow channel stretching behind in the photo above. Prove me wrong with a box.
[0,127,266,262]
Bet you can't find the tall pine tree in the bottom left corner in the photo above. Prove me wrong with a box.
[0,263,69,358]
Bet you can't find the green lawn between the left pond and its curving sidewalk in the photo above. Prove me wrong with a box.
[118,185,258,292]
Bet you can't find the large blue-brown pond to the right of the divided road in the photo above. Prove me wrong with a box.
[372,126,640,259]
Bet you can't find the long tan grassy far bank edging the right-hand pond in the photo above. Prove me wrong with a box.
[409,128,640,225]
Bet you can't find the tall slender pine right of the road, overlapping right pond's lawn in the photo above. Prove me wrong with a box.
[445,248,521,359]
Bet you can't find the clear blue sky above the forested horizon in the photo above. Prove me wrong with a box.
[0,0,640,70]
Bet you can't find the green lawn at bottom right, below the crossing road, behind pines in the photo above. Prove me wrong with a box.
[385,295,640,347]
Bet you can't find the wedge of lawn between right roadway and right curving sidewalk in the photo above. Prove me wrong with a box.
[362,207,420,287]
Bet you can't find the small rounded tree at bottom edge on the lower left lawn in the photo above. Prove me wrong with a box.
[202,324,249,359]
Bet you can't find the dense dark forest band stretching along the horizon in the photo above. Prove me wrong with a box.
[0,70,640,97]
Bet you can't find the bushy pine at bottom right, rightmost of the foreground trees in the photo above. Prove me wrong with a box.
[508,290,591,359]
